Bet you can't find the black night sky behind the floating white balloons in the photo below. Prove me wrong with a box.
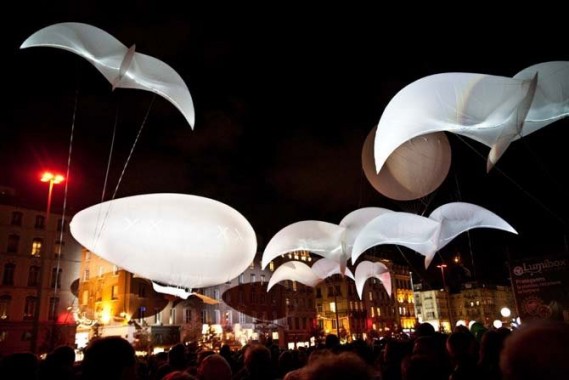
[0,1,569,286]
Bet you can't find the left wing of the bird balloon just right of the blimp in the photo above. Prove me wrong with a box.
[261,220,345,268]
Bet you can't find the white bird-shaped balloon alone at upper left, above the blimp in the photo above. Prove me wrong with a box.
[20,22,195,129]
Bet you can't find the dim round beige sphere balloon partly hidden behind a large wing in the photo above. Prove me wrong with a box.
[362,127,451,201]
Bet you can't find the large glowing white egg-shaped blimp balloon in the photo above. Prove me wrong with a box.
[70,193,257,290]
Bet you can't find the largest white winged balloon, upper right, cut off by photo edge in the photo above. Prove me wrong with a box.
[374,61,569,173]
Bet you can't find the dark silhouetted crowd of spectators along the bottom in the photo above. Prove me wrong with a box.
[0,320,569,380]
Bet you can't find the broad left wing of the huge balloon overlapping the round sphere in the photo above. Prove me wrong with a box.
[374,73,535,173]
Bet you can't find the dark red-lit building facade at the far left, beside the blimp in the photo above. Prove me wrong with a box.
[0,198,81,354]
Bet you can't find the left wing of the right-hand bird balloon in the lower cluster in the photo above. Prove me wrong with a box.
[352,211,440,264]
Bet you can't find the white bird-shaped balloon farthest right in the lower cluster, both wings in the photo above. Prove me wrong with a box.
[352,202,517,268]
